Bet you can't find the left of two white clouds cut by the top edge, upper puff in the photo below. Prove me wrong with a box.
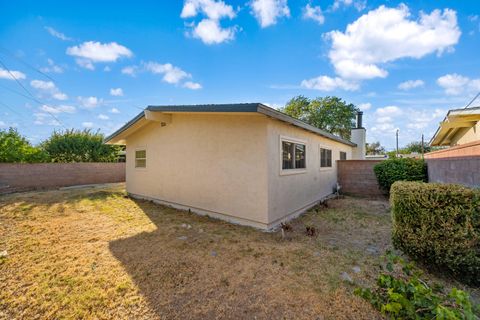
[180,0,236,20]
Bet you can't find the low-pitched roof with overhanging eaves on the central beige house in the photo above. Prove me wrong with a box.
[105,103,356,146]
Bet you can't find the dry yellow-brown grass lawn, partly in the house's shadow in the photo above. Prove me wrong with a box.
[0,184,476,319]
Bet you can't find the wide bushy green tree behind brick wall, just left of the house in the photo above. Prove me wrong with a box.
[41,129,120,162]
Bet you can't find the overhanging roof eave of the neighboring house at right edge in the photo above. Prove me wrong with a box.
[430,106,480,146]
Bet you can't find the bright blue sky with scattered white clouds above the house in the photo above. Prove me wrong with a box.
[0,0,480,149]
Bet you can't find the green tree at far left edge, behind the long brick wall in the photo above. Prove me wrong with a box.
[0,128,48,162]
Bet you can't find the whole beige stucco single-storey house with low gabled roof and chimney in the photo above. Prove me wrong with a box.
[106,103,365,229]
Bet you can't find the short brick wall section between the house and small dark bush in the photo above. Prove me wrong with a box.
[337,160,383,196]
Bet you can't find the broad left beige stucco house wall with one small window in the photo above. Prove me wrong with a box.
[127,114,268,228]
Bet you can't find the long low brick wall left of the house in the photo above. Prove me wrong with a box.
[0,163,125,193]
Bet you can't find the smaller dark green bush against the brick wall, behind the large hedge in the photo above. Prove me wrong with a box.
[373,158,428,193]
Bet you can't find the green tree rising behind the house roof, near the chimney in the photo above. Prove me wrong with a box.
[281,95,358,139]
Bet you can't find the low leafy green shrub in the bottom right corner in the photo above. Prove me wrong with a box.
[355,252,479,319]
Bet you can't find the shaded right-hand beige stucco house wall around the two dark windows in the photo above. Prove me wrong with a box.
[268,120,352,225]
